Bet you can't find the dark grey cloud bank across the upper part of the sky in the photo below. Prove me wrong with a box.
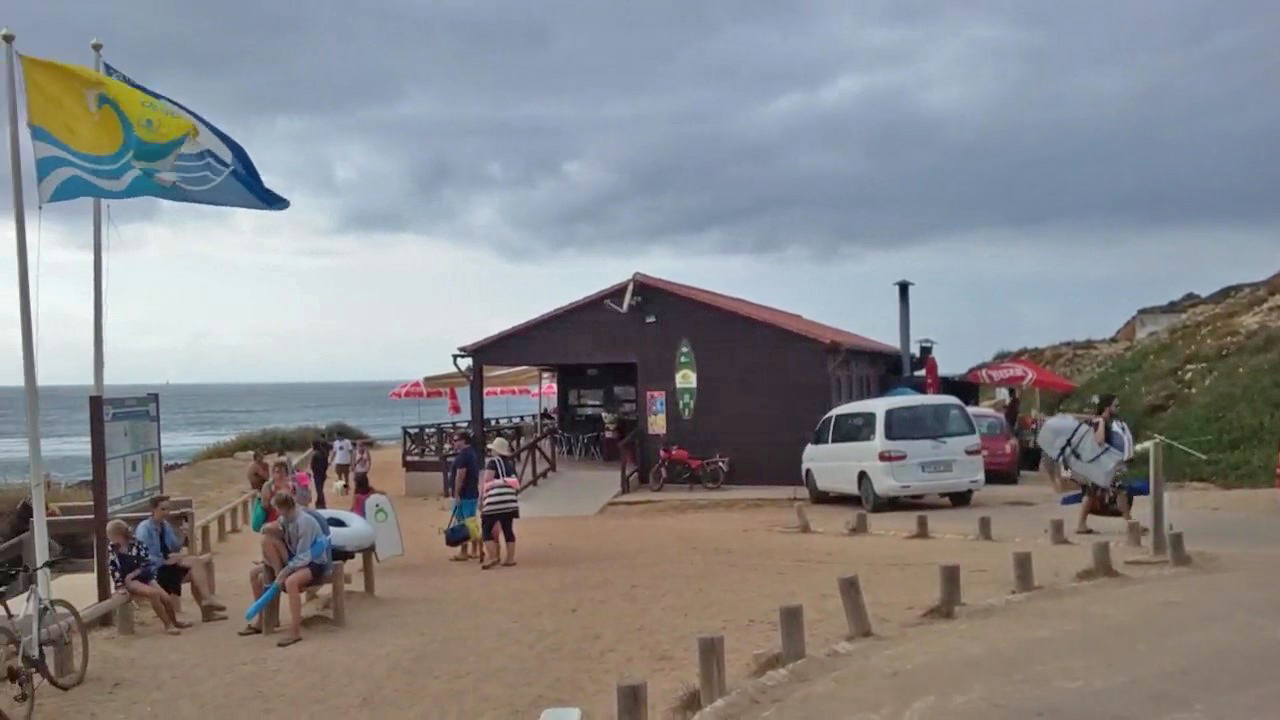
[8,0,1280,252]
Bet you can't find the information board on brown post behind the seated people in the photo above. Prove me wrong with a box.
[88,393,164,601]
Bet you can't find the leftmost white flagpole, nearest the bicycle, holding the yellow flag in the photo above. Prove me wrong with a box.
[0,28,49,597]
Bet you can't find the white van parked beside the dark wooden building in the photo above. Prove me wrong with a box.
[800,395,984,512]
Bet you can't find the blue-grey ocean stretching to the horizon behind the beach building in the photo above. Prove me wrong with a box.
[0,382,538,484]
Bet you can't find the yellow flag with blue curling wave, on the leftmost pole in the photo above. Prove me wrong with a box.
[20,55,197,202]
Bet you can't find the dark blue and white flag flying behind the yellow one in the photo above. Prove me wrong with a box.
[99,63,289,210]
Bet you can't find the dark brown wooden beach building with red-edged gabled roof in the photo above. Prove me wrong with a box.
[460,273,901,484]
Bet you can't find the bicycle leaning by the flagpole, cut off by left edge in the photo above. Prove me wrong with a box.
[0,560,88,720]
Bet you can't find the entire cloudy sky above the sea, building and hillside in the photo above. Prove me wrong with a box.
[0,0,1280,384]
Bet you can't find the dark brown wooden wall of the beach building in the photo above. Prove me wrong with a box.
[475,286,881,484]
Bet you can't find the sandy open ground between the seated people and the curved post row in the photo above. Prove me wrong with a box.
[32,448,1177,719]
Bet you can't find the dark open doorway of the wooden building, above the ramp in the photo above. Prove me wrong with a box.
[556,363,640,465]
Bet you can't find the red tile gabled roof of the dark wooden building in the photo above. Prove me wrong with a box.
[458,273,900,355]
